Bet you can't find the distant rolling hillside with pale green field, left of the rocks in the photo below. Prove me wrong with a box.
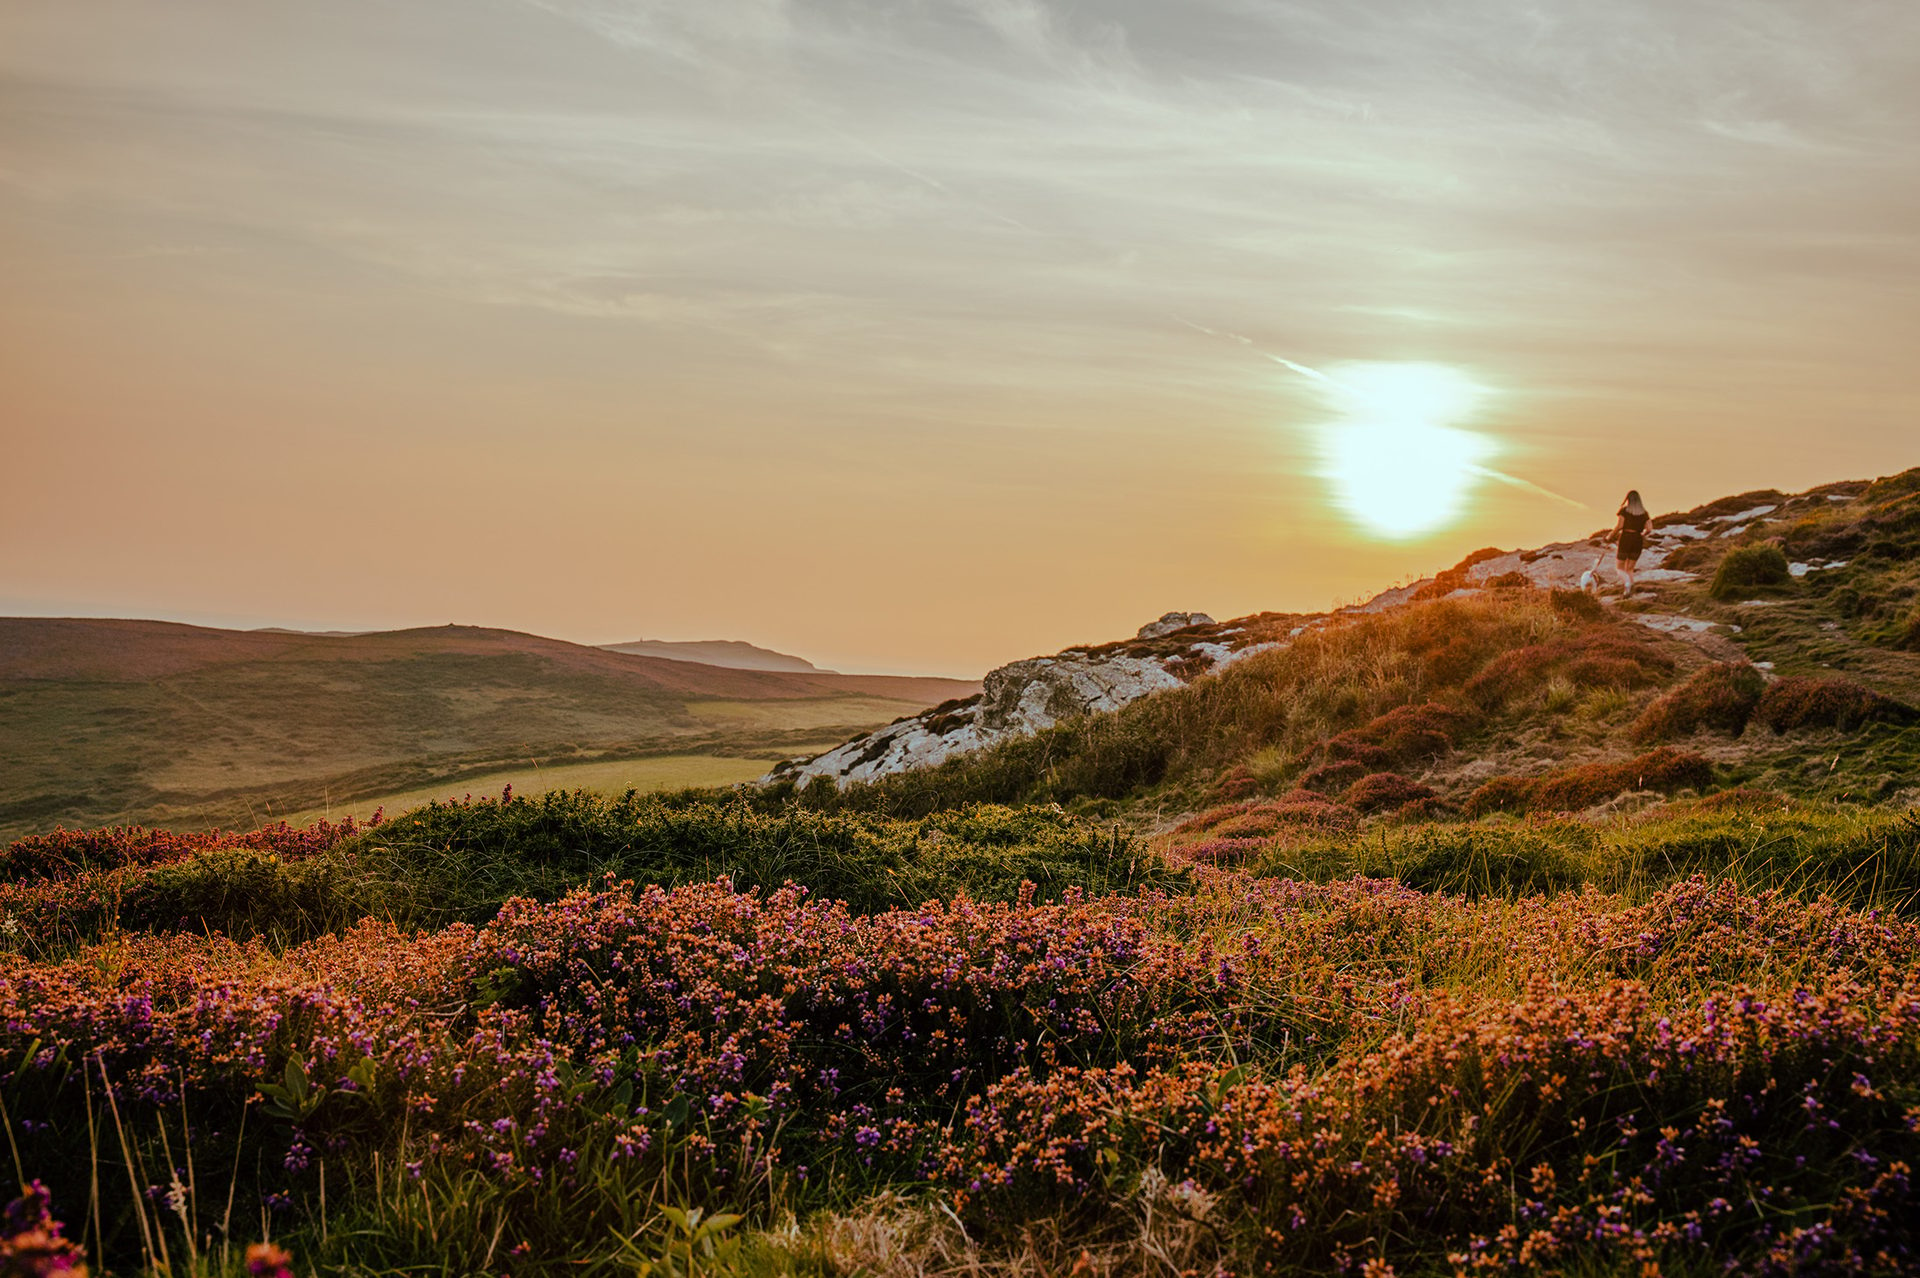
[0,618,973,835]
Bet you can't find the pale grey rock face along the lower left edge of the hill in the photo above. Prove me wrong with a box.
[766,612,1292,785]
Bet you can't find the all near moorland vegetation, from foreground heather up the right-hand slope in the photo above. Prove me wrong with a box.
[11,472,1920,1278]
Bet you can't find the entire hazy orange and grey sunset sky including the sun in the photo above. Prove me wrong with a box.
[0,0,1920,675]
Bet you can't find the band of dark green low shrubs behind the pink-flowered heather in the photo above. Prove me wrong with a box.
[0,791,1181,954]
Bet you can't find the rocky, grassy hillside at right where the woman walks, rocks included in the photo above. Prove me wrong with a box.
[768,470,1920,825]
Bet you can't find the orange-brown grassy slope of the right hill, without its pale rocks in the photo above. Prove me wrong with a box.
[768,472,1920,825]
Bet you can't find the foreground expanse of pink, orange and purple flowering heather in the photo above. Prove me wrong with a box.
[11,852,1920,1272]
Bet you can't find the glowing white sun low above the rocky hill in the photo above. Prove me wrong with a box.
[1321,363,1496,541]
